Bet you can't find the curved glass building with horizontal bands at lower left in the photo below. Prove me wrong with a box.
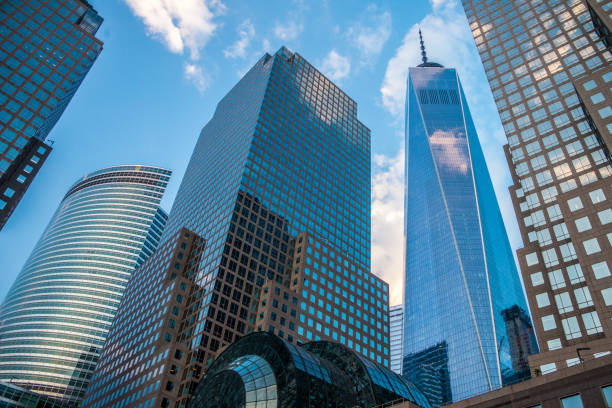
[0,166,171,405]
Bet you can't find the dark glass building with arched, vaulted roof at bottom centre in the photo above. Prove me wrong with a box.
[187,332,431,408]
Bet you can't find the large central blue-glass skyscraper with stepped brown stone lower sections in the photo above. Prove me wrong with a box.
[84,47,389,407]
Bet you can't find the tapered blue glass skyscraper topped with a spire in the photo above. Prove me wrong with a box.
[403,35,536,405]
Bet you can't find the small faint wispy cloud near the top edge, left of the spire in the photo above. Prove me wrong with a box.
[347,5,391,63]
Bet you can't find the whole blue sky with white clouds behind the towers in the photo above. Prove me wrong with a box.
[0,0,520,304]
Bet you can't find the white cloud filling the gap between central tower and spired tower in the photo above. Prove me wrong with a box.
[372,148,404,305]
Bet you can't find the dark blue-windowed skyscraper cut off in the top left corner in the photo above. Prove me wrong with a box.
[0,0,102,230]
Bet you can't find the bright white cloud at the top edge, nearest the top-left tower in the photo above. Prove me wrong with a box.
[124,0,225,60]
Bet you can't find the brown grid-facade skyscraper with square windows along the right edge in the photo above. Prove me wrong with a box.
[463,0,612,373]
